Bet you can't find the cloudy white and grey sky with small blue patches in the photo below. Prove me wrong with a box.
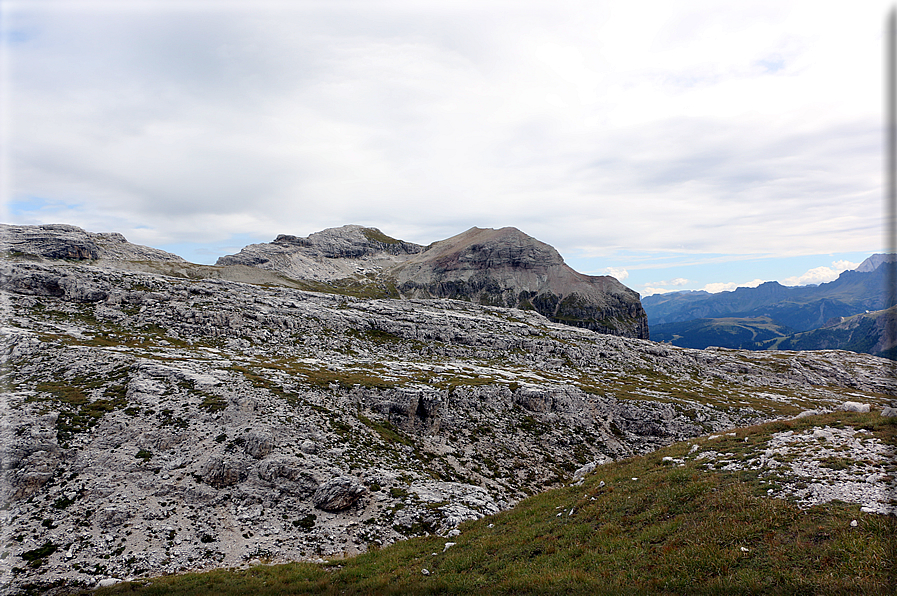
[0,0,890,296]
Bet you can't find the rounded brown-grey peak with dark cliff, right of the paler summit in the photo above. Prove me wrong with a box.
[390,228,648,339]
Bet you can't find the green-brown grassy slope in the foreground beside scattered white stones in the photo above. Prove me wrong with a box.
[96,412,897,596]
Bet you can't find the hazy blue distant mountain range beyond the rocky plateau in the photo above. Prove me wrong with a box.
[642,255,895,358]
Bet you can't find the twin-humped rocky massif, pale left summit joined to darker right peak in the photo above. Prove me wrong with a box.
[217,225,648,339]
